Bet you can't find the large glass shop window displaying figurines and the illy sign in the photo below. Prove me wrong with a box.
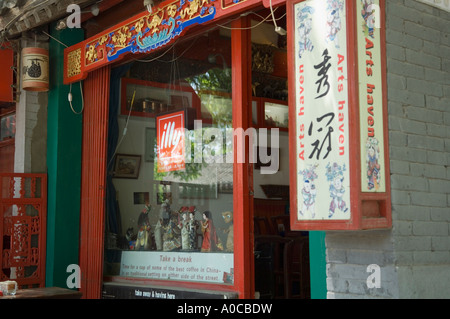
[104,30,234,285]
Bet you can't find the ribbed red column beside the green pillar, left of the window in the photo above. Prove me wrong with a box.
[80,66,110,299]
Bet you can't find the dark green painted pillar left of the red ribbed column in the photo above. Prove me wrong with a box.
[46,25,84,288]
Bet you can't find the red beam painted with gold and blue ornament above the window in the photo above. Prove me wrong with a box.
[64,0,260,84]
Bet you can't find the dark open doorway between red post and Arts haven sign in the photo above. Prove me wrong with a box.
[249,6,310,299]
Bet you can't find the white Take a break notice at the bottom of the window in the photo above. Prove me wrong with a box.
[120,251,234,284]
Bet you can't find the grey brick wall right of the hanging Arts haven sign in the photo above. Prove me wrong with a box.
[326,0,450,298]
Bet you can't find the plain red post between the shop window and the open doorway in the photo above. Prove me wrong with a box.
[231,18,255,299]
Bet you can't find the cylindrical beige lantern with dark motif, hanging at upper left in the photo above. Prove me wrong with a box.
[22,48,49,92]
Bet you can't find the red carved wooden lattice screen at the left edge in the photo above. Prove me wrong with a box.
[0,173,47,288]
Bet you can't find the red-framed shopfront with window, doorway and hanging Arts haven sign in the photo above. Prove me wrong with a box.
[64,0,390,299]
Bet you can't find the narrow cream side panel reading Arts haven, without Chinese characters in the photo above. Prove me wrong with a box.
[356,0,386,192]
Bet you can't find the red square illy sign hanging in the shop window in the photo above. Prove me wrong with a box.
[156,111,185,173]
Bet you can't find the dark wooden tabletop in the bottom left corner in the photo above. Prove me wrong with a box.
[0,287,82,299]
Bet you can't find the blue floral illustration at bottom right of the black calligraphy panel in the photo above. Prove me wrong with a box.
[325,163,348,218]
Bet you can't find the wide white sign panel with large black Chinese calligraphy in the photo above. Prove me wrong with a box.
[293,0,351,221]
